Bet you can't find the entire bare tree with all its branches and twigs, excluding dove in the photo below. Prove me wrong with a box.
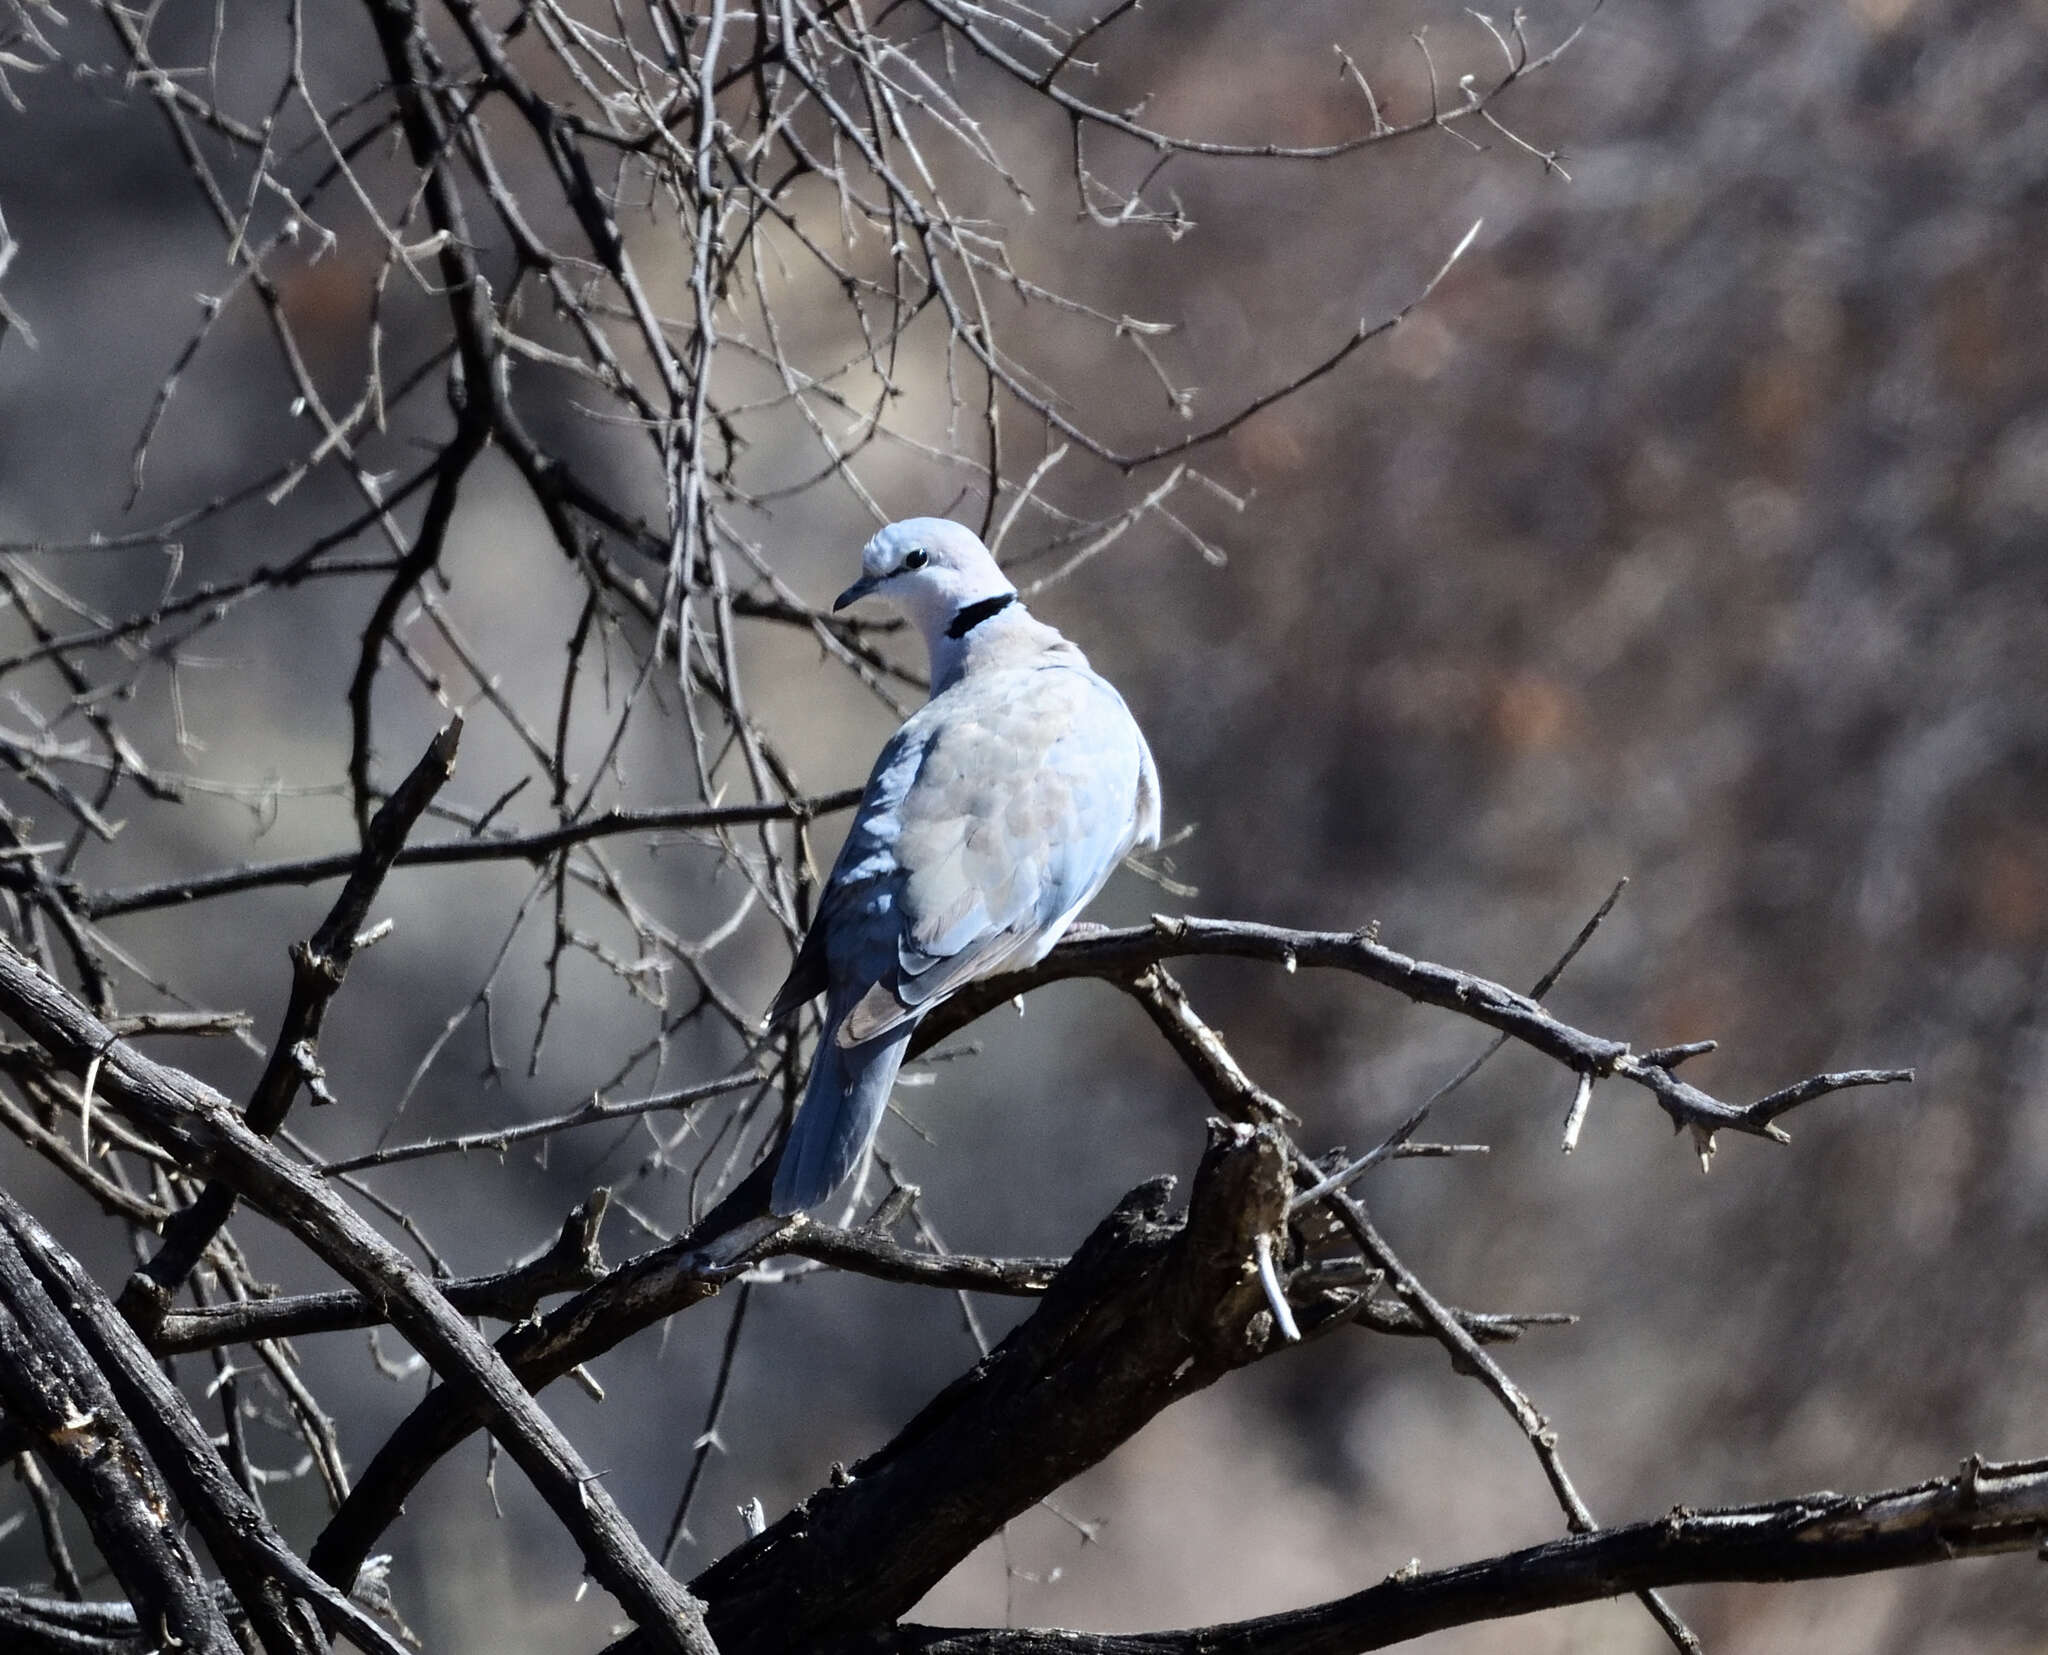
[0,0,2023,1655]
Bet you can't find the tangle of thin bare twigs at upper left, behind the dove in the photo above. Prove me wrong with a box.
[0,0,1569,1122]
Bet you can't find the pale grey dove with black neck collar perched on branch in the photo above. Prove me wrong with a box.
[768,518,1159,1213]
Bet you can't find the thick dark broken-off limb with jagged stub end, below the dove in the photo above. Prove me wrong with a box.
[692,1127,1288,1655]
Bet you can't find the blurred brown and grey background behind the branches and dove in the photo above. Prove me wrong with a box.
[0,0,2048,1655]
